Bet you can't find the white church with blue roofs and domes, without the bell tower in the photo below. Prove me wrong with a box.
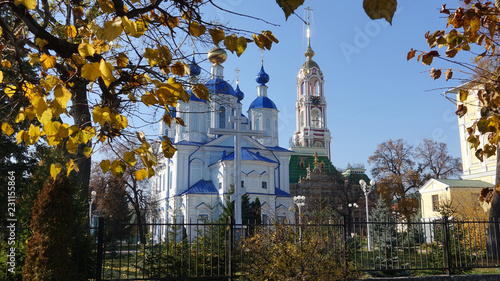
[151,47,293,230]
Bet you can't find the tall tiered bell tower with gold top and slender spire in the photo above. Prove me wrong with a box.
[291,7,332,160]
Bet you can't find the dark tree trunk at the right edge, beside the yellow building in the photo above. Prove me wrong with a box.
[486,144,500,257]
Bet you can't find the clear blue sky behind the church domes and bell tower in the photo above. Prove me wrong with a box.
[143,0,468,175]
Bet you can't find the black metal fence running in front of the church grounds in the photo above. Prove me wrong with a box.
[0,218,500,280]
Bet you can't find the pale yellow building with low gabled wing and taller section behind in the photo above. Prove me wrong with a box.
[419,84,496,221]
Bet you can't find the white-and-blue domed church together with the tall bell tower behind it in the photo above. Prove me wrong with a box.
[151,16,331,223]
